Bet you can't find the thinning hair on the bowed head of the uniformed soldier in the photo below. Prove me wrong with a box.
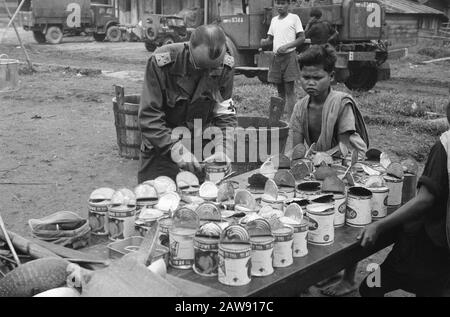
[189,24,227,59]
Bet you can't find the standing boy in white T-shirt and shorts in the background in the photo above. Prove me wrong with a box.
[261,0,305,117]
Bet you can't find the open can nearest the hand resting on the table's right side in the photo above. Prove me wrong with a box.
[346,187,372,228]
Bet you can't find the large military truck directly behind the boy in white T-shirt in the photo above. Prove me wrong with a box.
[204,0,390,90]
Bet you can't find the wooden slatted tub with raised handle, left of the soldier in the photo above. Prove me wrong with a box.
[113,95,141,160]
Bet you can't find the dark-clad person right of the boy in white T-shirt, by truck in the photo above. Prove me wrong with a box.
[305,8,339,45]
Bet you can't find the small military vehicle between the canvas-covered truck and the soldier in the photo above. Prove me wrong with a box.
[144,14,193,52]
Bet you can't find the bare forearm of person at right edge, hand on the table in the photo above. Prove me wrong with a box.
[358,186,435,247]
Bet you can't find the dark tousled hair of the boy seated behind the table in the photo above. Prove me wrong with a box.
[299,44,337,73]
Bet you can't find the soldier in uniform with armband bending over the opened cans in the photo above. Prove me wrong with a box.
[138,25,237,183]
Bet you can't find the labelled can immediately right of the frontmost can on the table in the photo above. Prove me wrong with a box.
[250,236,275,276]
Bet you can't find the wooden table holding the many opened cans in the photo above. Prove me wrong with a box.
[82,172,394,297]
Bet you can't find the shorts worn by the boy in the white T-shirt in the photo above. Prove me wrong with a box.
[268,51,300,84]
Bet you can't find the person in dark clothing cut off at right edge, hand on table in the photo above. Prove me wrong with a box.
[359,103,450,297]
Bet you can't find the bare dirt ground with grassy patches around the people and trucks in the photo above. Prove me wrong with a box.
[0,29,450,296]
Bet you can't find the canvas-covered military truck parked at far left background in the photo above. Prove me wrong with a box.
[21,0,122,44]
